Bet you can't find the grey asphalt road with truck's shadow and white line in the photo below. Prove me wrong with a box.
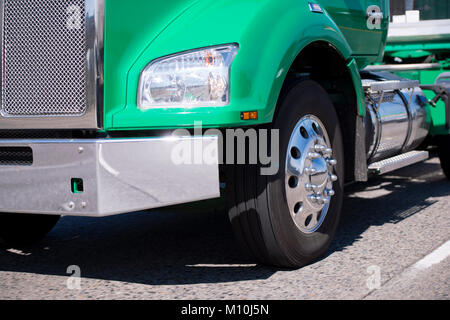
[0,159,450,300]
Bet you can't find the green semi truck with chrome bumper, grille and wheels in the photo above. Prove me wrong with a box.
[0,0,450,268]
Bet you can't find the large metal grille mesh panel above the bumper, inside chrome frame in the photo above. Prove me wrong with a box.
[2,0,87,117]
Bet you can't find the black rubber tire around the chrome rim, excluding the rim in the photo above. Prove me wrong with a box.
[227,81,344,268]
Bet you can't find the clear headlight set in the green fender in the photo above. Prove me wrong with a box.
[137,44,238,109]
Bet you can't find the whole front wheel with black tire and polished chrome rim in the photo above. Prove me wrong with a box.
[227,81,344,268]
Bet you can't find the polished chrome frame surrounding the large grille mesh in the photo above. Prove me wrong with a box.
[0,0,105,129]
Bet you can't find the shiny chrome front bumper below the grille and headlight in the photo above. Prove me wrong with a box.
[0,137,220,217]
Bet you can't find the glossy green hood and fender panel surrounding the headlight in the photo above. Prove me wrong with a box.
[105,0,365,130]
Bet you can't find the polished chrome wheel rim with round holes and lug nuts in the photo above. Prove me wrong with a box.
[285,115,338,233]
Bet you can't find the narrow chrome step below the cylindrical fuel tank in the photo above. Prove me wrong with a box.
[369,151,430,175]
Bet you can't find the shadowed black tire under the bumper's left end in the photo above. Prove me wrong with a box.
[0,213,60,247]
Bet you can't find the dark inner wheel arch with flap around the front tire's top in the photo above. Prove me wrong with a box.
[274,40,367,181]
